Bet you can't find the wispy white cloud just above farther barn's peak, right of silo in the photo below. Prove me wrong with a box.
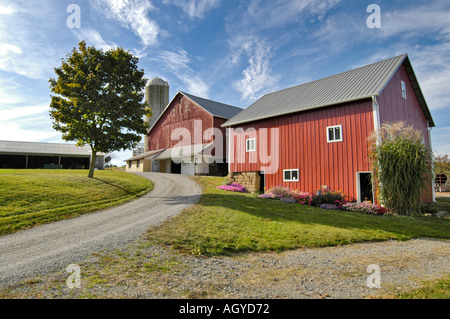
[156,50,209,98]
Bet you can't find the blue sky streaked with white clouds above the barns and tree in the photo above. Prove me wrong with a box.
[0,0,450,164]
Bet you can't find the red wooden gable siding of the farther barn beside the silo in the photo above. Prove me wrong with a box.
[148,93,214,151]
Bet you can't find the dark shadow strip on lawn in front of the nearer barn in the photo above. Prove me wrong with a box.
[195,193,450,239]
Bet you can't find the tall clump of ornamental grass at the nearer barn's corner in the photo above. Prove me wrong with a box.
[369,122,433,215]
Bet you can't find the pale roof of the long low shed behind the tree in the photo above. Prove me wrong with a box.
[0,141,104,156]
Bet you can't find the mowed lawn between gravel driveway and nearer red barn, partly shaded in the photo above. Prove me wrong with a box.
[148,177,450,256]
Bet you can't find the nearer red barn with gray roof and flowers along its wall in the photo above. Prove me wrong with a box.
[223,54,434,201]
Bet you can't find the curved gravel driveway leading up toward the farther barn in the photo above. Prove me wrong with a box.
[0,173,201,287]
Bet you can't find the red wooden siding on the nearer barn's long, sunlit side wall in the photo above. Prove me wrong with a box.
[230,100,374,198]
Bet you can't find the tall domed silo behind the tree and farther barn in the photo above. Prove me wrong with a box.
[144,77,169,152]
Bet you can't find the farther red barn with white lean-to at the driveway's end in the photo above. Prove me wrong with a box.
[139,92,242,176]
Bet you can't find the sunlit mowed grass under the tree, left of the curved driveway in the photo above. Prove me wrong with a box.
[0,169,153,235]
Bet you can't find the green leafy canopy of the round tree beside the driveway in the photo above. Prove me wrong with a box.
[49,41,147,152]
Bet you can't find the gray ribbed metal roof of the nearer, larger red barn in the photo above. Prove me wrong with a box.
[222,54,434,126]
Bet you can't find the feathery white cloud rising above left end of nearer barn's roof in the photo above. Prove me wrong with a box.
[231,37,279,101]
